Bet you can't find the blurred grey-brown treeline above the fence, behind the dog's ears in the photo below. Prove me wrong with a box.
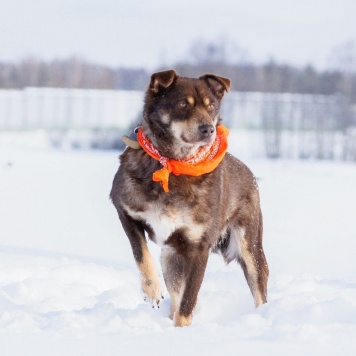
[0,57,356,103]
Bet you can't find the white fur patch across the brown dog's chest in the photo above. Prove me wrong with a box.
[125,204,204,247]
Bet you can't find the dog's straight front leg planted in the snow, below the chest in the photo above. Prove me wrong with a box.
[162,238,209,326]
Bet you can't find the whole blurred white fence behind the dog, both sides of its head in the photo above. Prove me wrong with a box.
[0,88,356,160]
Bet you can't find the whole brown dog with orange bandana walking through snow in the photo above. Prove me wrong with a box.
[110,70,269,326]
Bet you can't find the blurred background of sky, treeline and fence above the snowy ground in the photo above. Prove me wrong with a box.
[0,0,356,161]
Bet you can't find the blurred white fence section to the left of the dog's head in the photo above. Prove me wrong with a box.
[0,88,143,130]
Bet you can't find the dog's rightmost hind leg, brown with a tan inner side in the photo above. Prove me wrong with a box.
[237,217,269,308]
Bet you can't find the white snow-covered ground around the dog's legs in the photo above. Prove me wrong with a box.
[0,138,356,356]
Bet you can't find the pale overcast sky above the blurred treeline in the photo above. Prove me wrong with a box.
[0,0,356,69]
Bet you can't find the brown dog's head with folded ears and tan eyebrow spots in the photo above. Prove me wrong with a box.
[143,70,230,159]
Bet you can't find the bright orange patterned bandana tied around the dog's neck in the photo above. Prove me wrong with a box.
[137,125,229,193]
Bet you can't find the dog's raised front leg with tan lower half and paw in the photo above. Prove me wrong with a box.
[119,210,163,306]
